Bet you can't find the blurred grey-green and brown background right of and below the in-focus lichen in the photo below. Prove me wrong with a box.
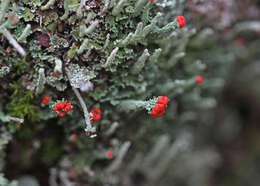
[1,0,260,186]
